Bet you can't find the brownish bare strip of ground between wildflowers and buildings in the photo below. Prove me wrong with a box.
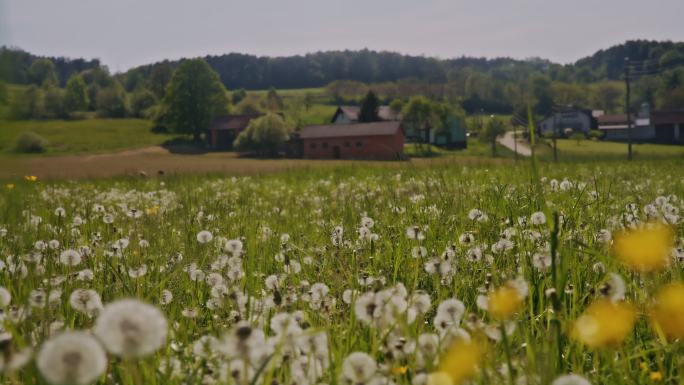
[0,147,503,180]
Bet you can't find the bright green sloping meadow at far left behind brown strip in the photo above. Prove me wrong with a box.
[0,119,175,155]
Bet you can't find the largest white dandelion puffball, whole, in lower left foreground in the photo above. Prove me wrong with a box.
[94,299,167,357]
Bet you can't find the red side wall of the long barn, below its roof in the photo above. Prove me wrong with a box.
[302,131,404,160]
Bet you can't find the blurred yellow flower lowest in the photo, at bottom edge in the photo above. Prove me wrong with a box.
[428,340,484,385]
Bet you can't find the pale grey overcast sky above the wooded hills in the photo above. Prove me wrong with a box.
[0,0,684,71]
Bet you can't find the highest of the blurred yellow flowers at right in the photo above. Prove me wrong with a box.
[613,223,674,272]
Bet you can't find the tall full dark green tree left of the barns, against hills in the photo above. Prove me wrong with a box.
[164,59,228,141]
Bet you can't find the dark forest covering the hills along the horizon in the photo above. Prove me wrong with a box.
[0,40,684,115]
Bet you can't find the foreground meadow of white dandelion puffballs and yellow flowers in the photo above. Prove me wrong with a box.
[0,161,684,385]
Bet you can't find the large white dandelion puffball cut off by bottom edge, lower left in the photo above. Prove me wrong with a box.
[36,332,107,385]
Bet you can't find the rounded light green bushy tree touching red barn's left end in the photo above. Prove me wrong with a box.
[233,113,290,156]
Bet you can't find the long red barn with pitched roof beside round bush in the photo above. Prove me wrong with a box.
[299,121,404,160]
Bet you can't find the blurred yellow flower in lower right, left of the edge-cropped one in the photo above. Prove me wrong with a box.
[572,299,636,348]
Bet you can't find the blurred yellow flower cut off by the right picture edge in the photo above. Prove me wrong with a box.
[651,282,684,339]
